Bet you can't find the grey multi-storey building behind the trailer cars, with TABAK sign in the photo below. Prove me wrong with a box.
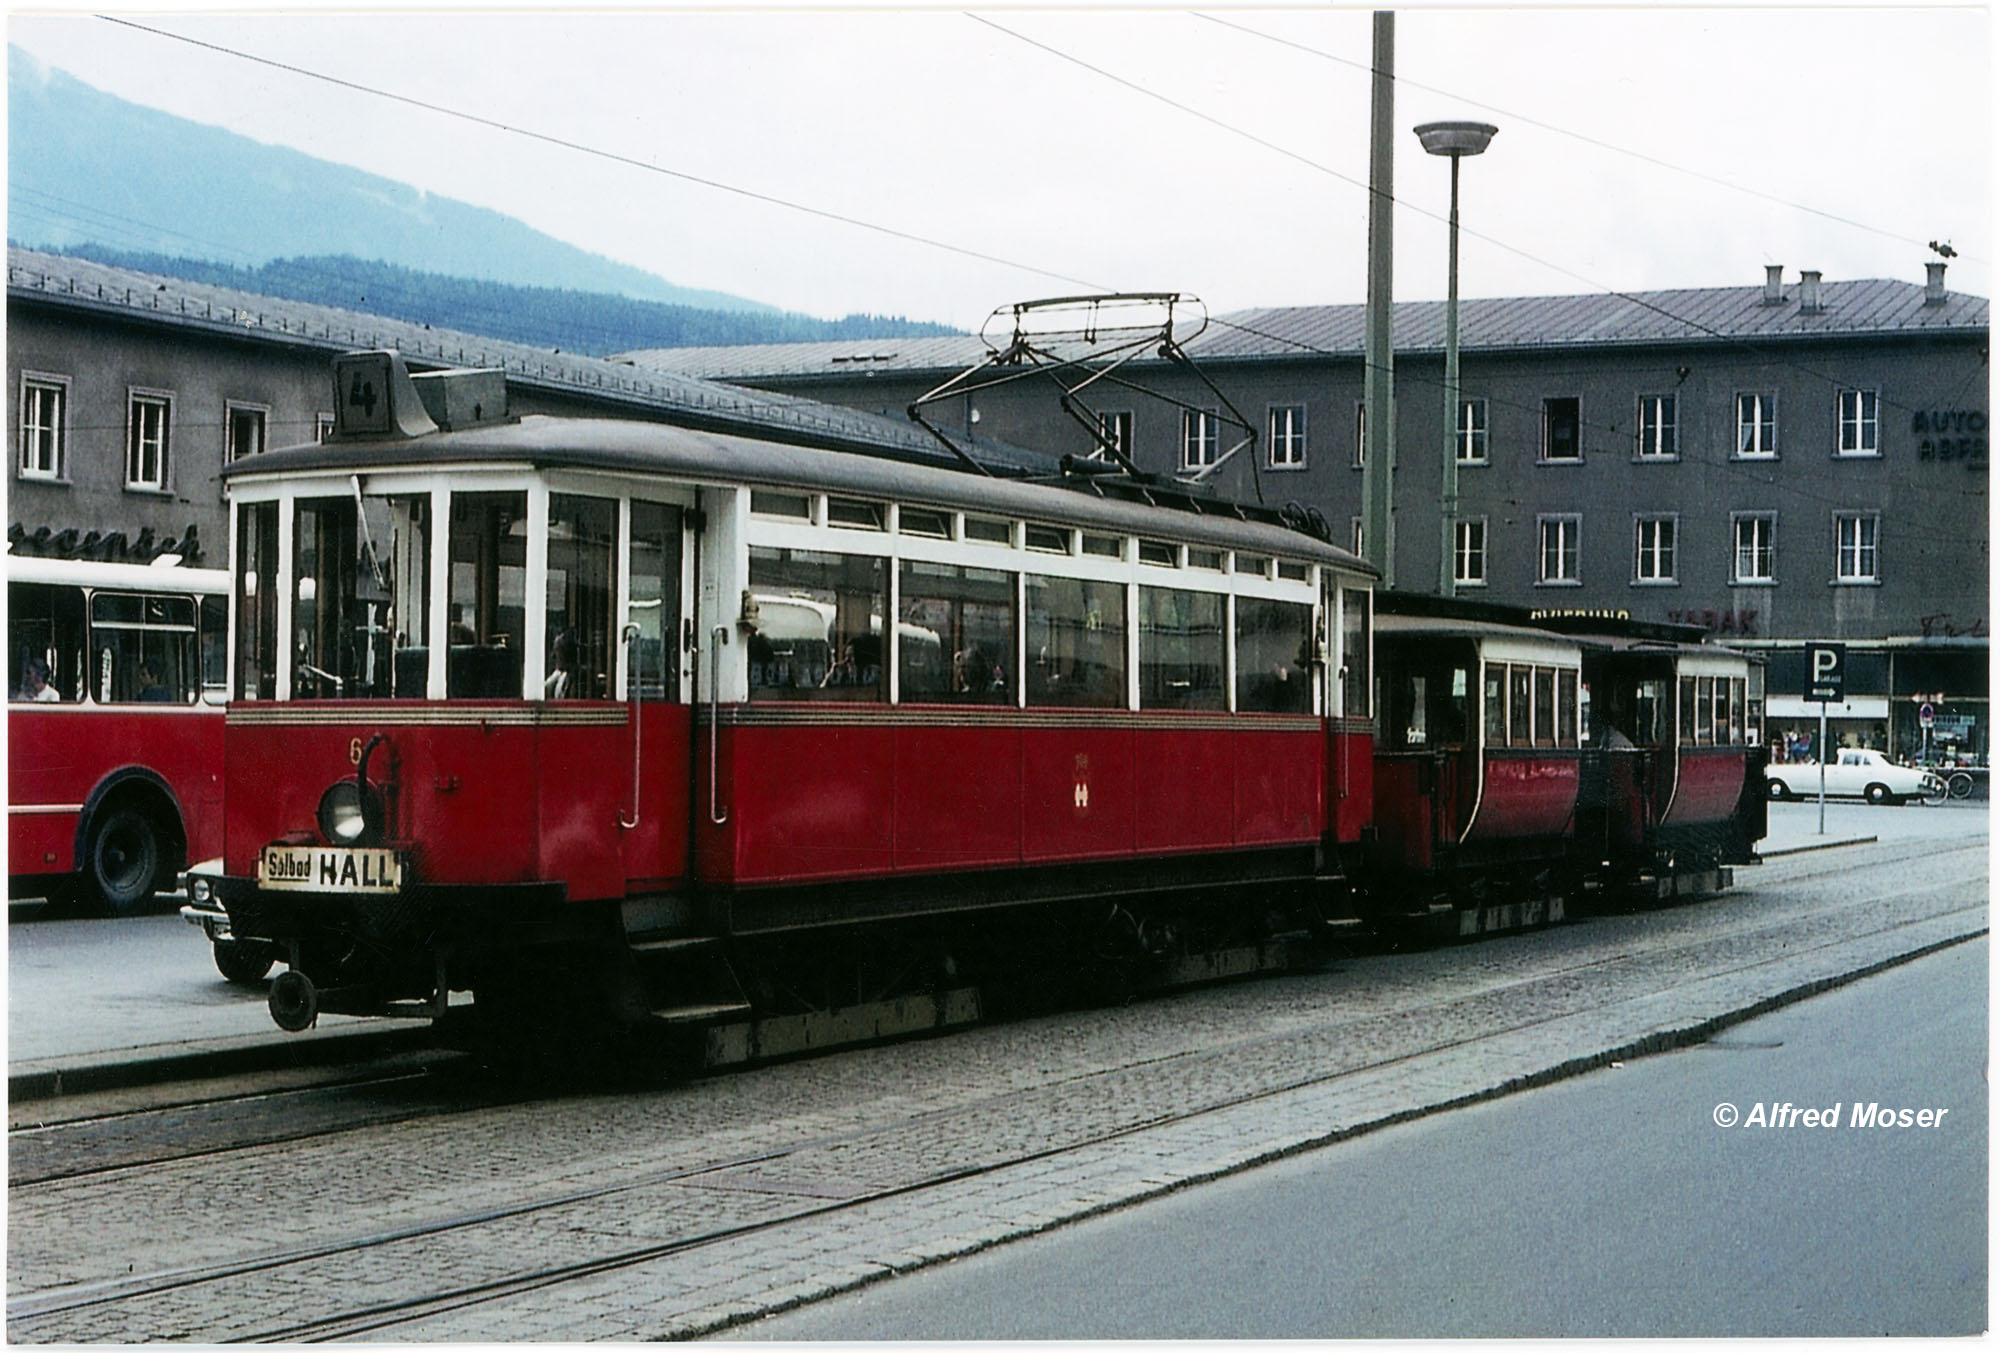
[624,264,1988,765]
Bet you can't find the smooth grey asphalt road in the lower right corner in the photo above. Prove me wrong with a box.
[728,941,1988,1341]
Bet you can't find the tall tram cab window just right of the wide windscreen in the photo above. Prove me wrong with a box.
[444,492,528,701]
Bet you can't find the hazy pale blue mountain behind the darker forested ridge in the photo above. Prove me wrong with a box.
[8,46,936,332]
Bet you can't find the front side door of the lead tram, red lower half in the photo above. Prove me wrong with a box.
[616,498,694,891]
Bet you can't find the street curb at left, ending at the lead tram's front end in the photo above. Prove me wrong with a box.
[6,1025,436,1105]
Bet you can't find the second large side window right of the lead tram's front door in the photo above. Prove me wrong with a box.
[896,560,1016,705]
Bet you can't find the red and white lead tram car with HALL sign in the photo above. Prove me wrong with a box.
[212,354,1374,1055]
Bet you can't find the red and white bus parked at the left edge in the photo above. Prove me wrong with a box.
[6,554,228,915]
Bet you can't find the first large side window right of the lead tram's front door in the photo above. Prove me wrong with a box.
[750,544,888,701]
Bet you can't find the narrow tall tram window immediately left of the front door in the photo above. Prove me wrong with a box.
[542,492,618,701]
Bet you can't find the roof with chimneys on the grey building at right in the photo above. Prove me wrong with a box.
[616,280,1988,380]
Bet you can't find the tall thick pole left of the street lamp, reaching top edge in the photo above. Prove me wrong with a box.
[1362,10,1396,586]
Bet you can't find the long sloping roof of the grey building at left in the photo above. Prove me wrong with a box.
[6,248,1054,472]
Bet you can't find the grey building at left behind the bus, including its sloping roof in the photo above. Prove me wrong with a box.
[6,248,996,566]
